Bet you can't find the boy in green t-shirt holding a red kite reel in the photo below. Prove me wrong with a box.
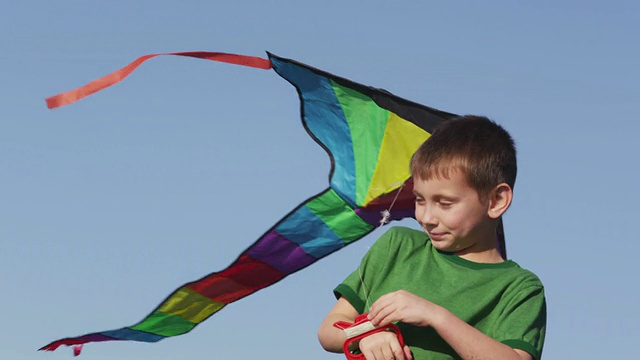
[318,116,546,360]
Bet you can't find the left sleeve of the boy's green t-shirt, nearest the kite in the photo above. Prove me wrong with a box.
[333,228,395,314]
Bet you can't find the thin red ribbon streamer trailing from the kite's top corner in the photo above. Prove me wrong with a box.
[46,51,271,109]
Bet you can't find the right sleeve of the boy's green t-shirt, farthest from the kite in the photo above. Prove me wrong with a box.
[495,283,547,360]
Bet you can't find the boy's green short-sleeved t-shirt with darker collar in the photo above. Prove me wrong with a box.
[334,227,546,360]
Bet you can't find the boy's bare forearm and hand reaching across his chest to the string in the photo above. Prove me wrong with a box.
[369,290,533,360]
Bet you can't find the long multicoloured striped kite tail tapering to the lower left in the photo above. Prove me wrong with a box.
[40,189,380,351]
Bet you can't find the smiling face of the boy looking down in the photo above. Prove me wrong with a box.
[413,171,495,255]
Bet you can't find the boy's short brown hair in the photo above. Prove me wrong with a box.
[410,115,518,198]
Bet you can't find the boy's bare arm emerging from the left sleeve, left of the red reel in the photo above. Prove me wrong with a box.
[318,297,359,353]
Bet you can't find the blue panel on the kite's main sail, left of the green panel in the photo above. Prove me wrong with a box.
[271,57,356,207]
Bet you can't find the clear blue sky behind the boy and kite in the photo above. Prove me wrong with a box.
[0,0,640,360]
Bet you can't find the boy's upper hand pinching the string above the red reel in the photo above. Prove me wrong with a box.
[369,290,446,327]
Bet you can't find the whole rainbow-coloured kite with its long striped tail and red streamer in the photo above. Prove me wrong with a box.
[40,52,504,353]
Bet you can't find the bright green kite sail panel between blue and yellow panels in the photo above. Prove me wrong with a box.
[332,81,389,206]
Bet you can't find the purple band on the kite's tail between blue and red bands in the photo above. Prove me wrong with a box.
[247,230,318,274]
